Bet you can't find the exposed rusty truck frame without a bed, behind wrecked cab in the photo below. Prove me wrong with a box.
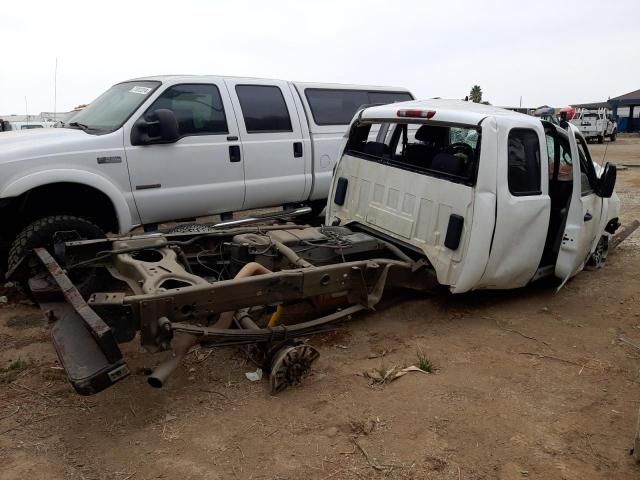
[29,209,435,395]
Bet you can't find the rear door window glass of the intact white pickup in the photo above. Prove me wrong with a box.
[236,85,292,133]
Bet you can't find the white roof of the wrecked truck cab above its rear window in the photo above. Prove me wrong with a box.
[360,99,540,125]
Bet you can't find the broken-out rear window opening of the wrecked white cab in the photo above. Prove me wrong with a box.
[346,123,480,185]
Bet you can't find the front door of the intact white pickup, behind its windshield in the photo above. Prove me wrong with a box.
[125,80,245,223]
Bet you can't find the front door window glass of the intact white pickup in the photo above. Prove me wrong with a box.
[147,84,228,137]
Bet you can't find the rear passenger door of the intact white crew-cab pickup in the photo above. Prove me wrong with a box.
[225,78,311,209]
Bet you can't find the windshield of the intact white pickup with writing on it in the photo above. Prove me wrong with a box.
[67,81,160,133]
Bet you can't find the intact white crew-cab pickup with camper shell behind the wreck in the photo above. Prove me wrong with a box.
[0,76,413,274]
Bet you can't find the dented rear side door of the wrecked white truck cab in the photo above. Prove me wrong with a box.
[481,120,551,288]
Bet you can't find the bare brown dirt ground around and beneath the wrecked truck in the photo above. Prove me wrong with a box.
[0,136,640,480]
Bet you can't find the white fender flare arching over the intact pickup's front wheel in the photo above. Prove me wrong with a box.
[0,168,133,232]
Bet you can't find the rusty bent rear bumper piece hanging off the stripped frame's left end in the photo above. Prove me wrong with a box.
[29,248,130,395]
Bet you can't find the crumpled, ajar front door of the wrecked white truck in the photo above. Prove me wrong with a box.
[555,125,602,287]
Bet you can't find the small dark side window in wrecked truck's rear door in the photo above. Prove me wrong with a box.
[508,128,541,195]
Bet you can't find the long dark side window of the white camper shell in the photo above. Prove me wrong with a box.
[304,88,413,125]
